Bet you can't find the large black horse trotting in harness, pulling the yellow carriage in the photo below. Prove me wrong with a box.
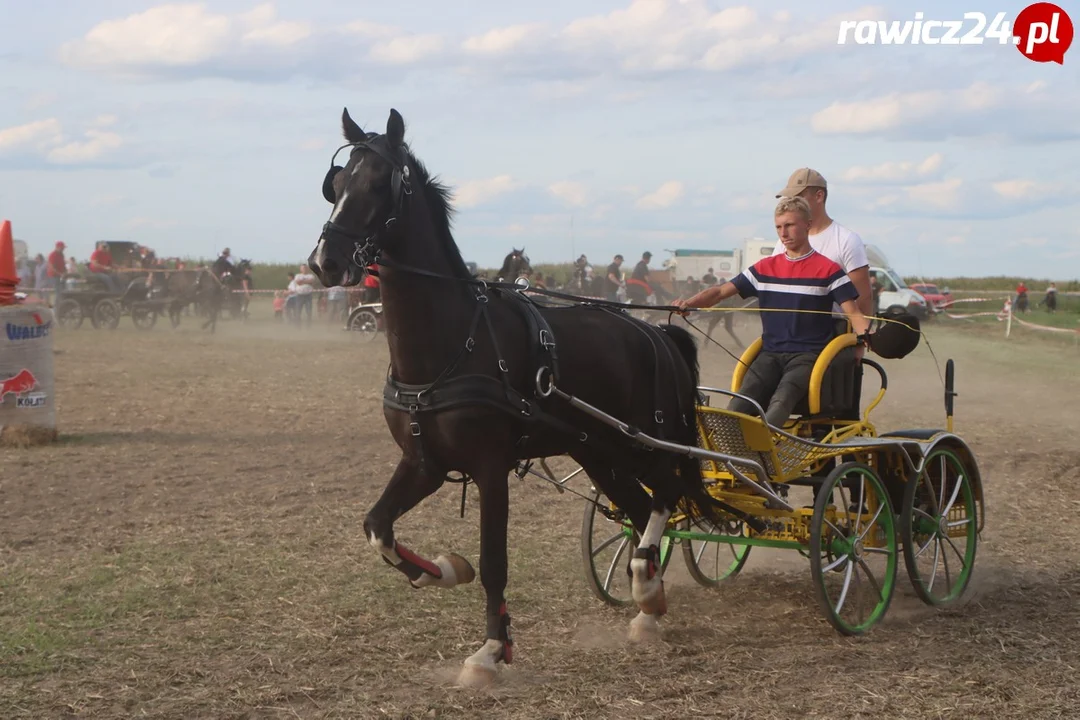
[308,110,719,683]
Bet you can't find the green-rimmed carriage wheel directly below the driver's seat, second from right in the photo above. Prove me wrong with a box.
[810,462,900,635]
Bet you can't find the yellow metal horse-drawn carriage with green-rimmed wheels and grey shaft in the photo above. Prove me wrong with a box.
[561,334,984,635]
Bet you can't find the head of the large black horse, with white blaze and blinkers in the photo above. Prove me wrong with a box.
[308,109,413,287]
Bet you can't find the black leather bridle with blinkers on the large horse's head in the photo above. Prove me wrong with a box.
[323,133,413,270]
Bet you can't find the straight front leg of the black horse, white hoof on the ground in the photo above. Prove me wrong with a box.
[458,463,513,687]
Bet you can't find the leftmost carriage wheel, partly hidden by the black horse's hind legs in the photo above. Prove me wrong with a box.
[581,483,674,608]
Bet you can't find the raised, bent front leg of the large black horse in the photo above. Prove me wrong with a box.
[364,457,476,587]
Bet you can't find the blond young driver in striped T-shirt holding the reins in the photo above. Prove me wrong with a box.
[674,198,869,427]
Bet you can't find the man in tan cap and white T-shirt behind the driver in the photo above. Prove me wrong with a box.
[772,167,874,317]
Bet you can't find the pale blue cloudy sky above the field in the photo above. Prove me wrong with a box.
[0,0,1080,280]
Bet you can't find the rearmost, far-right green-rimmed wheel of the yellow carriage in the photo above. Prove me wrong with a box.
[900,448,978,607]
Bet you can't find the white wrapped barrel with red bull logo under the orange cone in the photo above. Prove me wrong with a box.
[0,305,56,440]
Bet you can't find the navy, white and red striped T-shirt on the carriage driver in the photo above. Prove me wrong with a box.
[731,249,859,353]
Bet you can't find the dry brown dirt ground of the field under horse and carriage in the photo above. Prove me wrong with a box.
[0,310,1080,720]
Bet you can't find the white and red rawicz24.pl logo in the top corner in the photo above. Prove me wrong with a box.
[836,2,1072,65]
